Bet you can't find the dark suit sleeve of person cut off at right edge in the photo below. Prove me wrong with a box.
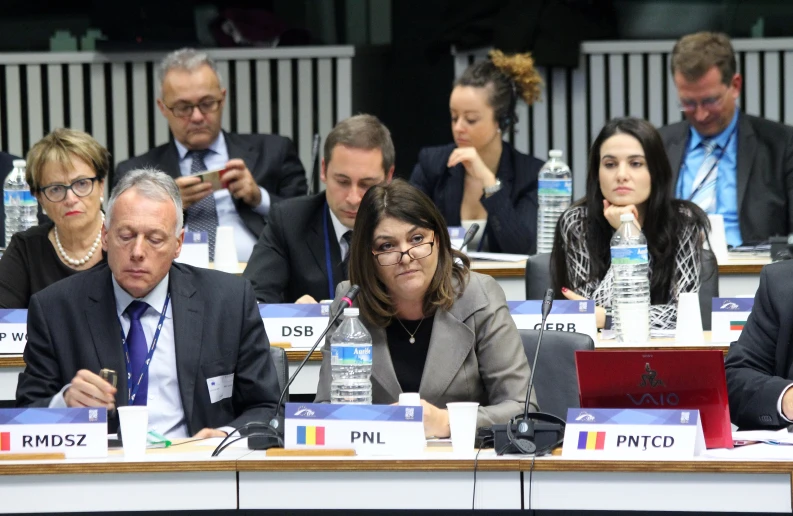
[724,261,793,430]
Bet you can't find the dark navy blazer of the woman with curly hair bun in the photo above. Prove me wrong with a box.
[410,142,543,254]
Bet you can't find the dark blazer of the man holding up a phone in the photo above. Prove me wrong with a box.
[113,131,308,238]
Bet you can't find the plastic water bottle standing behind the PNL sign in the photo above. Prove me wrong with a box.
[330,308,372,405]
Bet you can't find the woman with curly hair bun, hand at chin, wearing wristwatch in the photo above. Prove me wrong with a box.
[410,50,543,254]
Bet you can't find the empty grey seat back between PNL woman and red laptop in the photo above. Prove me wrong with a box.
[518,330,595,420]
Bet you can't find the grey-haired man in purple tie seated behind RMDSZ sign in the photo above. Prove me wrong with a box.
[16,170,279,438]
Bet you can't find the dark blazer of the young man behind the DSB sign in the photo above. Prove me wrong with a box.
[242,196,344,303]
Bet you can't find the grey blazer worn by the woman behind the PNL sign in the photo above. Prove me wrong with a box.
[316,272,537,427]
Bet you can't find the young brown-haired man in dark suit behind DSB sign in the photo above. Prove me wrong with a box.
[243,115,395,303]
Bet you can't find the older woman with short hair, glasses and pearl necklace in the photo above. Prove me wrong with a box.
[0,129,110,308]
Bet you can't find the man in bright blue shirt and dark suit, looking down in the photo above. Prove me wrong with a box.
[660,32,793,246]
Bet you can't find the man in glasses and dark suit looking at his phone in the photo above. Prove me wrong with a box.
[114,48,307,261]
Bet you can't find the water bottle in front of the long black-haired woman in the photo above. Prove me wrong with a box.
[611,213,650,343]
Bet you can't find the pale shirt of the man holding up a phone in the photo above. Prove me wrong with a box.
[174,132,270,262]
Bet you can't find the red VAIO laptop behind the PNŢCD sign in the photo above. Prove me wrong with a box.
[575,349,732,448]
